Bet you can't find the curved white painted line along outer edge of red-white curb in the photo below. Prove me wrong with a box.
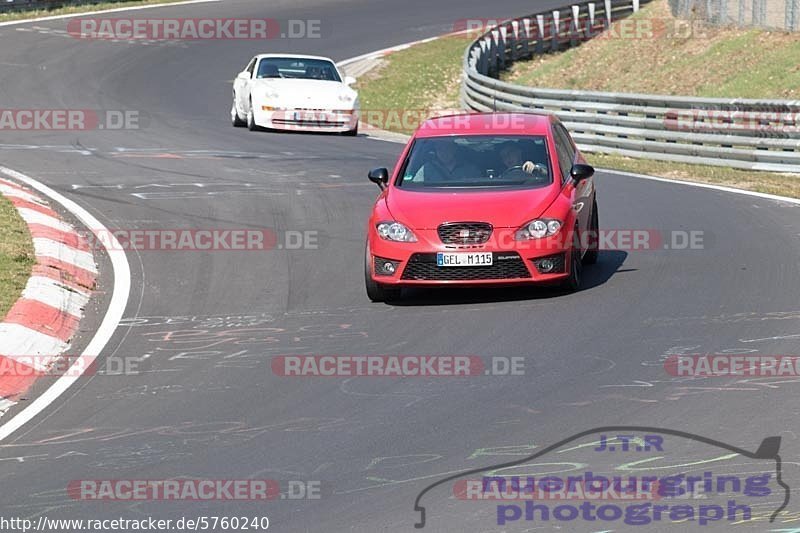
[0,166,130,441]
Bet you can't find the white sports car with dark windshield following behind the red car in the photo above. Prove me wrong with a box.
[231,54,359,135]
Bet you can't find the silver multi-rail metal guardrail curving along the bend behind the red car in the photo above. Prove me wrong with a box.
[461,0,800,173]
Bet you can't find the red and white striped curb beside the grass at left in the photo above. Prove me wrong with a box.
[0,178,97,416]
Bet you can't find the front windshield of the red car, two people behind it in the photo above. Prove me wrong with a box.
[396,135,552,190]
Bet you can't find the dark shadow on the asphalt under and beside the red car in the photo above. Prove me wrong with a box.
[387,250,636,307]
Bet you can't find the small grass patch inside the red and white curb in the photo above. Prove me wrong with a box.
[0,196,36,320]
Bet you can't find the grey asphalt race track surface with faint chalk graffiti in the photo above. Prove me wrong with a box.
[0,0,800,532]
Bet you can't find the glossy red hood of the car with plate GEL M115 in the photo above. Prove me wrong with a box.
[385,185,560,229]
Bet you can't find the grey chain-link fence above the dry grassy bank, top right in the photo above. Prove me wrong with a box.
[669,0,800,31]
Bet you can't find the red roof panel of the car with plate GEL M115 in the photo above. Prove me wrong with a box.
[414,113,553,137]
